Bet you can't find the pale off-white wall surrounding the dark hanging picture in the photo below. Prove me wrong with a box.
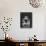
[0,0,46,40]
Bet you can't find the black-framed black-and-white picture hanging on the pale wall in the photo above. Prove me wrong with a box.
[20,12,32,28]
